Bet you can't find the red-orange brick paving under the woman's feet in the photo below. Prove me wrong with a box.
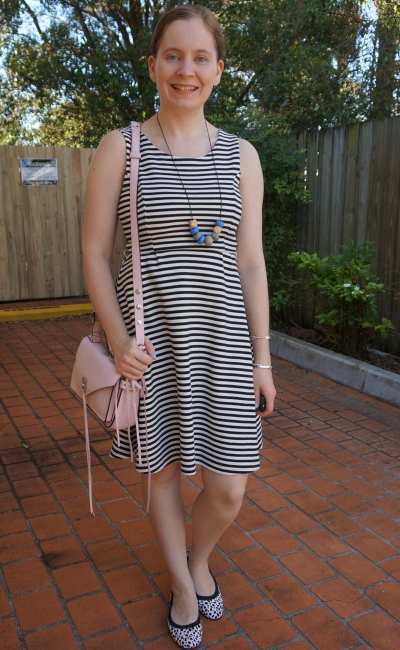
[0,318,400,650]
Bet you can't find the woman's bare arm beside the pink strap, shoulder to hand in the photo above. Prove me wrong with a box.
[83,131,154,379]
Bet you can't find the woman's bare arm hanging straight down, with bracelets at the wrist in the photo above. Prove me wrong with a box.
[237,140,276,415]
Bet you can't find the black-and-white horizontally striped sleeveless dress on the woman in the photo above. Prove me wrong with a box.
[111,127,262,475]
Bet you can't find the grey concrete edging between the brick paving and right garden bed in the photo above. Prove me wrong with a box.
[270,331,400,407]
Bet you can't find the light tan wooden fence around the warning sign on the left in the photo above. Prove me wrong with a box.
[0,145,125,302]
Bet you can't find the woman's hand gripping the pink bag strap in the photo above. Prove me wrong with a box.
[113,336,155,381]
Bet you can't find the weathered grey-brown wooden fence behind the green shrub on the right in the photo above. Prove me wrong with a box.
[298,117,400,354]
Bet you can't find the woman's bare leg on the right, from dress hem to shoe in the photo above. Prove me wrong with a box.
[189,467,247,596]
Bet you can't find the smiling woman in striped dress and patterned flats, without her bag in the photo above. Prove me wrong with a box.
[83,5,275,648]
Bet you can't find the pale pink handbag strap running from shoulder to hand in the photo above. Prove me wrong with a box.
[130,122,144,348]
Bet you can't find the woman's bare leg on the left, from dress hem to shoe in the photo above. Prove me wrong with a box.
[142,463,199,625]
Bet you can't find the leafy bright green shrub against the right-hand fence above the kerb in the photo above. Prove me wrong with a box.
[271,240,394,359]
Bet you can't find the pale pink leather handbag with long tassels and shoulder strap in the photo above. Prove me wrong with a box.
[71,122,151,515]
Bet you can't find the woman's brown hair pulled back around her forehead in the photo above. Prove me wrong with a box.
[150,5,225,61]
